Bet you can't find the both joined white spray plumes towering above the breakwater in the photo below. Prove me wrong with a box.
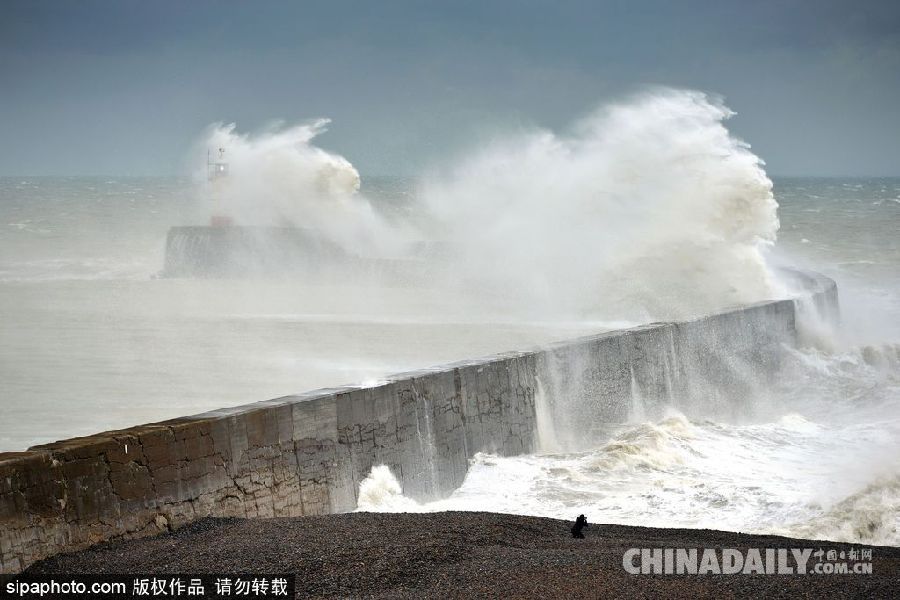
[196,89,780,323]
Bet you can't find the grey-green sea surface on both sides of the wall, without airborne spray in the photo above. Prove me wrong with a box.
[0,178,900,545]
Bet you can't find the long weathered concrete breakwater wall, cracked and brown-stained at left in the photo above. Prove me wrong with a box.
[0,272,836,573]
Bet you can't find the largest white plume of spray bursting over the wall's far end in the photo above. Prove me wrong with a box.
[422,90,778,322]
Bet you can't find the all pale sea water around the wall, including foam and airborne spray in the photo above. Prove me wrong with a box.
[0,90,900,544]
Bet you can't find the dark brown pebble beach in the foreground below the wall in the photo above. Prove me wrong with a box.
[26,512,900,598]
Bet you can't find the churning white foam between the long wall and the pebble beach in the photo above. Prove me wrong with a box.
[354,348,900,545]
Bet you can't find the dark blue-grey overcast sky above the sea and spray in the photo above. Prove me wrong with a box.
[0,0,900,175]
